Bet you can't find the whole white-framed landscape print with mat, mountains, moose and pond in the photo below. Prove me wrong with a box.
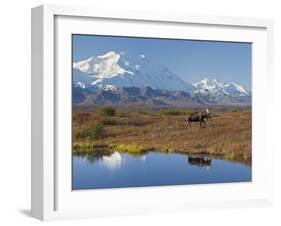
[32,5,273,220]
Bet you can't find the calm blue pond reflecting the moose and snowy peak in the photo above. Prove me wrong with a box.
[72,152,252,190]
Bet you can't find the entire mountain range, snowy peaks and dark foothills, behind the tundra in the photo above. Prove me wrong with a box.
[73,51,251,106]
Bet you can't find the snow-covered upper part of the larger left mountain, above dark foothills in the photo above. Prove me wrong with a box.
[73,51,194,91]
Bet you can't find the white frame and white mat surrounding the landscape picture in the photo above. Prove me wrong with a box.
[31,5,273,220]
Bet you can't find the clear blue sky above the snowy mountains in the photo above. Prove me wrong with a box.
[72,35,252,91]
